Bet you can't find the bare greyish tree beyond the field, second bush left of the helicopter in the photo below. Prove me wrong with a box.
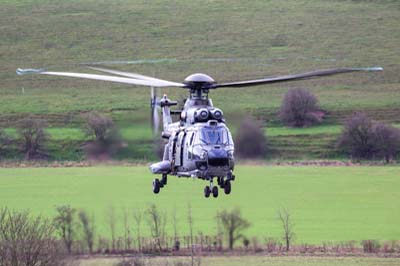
[17,118,49,160]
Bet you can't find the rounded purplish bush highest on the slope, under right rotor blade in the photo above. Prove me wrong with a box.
[279,88,323,127]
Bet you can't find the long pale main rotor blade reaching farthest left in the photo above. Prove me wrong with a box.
[17,69,181,87]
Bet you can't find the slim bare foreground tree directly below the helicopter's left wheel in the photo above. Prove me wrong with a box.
[146,204,166,251]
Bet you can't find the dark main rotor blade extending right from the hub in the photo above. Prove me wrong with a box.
[212,67,383,88]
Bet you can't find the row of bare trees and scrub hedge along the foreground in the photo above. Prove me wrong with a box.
[0,204,400,266]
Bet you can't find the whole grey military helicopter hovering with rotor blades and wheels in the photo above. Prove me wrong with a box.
[16,66,383,198]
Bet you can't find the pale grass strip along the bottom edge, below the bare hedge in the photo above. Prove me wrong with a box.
[79,256,400,266]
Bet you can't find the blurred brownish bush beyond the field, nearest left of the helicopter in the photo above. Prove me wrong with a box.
[85,113,121,159]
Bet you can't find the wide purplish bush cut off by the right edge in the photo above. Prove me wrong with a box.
[338,113,400,162]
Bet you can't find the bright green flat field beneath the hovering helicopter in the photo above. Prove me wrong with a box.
[0,165,400,244]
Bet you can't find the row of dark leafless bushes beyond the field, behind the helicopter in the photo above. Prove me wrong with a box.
[0,88,400,162]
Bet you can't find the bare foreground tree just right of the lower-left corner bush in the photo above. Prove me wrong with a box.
[54,205,76,254]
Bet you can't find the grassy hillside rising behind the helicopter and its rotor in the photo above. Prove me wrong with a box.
[0,0,400,159]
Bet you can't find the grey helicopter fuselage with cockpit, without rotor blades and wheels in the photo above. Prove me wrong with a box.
[150,94,234,180]
